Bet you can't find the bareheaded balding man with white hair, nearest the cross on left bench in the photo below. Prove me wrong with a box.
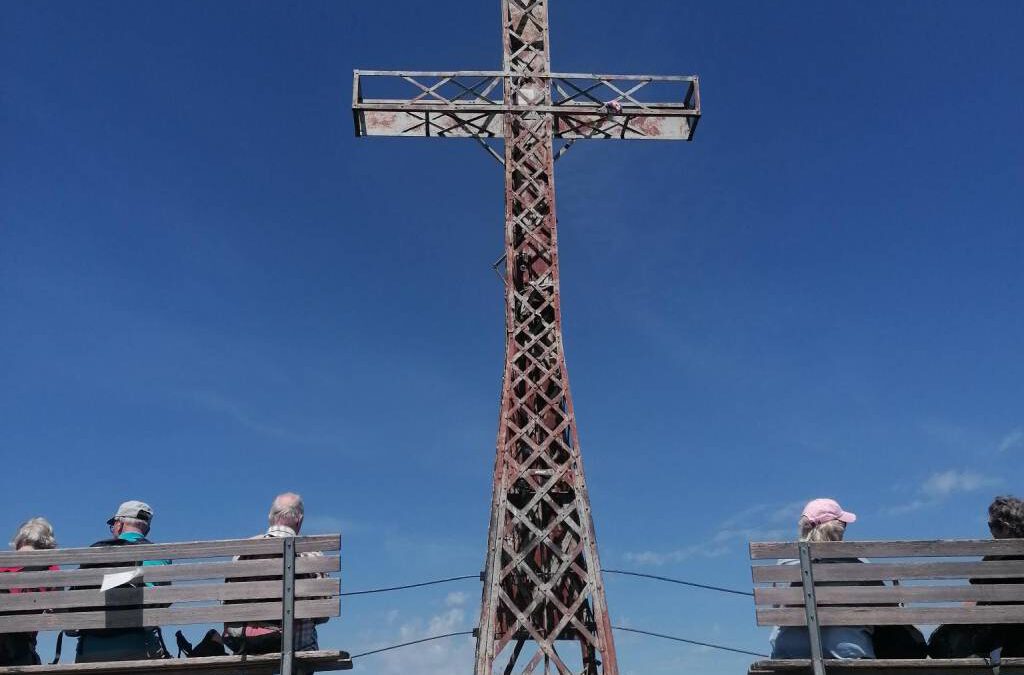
[224,493,327,653]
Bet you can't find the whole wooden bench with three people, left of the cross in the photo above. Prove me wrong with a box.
[0,535,352,675]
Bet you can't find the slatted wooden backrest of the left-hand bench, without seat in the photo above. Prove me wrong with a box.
[0,535,340,633]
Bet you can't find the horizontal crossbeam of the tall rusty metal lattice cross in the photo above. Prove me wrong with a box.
[352,71,700,140]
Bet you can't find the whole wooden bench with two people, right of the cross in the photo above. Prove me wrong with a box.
[750,539,1024,675]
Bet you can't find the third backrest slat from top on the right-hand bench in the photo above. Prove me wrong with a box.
[754,581,1024,606]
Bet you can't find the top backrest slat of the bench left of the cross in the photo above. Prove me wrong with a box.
[0,535,341,567]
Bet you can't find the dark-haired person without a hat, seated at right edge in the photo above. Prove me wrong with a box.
[928,496,1024,659]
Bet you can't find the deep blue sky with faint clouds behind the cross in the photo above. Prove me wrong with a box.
[0,0,1024,675]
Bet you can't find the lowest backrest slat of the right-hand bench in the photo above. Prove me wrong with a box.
[757,604,1024,626]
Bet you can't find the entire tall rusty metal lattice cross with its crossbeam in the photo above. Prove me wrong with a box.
[352,0,700,675]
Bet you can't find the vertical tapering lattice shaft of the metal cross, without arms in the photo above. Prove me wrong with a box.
[476,0,617,675]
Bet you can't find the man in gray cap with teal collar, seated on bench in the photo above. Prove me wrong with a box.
[75,500,171,663]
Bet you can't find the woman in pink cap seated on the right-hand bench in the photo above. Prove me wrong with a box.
[771,499,874,659]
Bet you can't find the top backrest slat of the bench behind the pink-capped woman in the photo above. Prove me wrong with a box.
[750,539,1024,560]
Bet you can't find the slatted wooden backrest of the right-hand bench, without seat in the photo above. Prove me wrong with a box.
[751,539,1024,626]
